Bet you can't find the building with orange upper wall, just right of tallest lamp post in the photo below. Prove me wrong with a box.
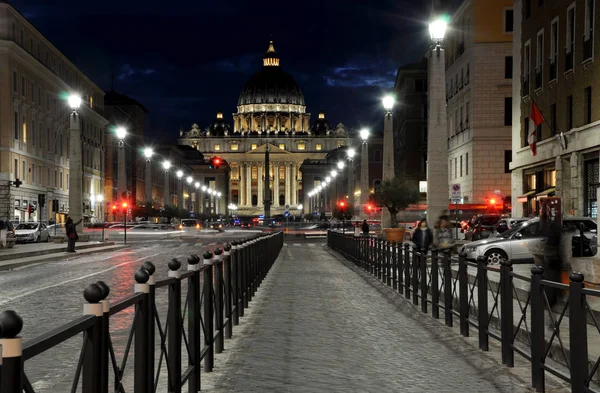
[444,0,514,204]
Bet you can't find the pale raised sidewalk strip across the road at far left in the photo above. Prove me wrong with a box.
[0,241,126,271]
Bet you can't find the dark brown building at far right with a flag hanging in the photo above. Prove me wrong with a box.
[511,0,600,217]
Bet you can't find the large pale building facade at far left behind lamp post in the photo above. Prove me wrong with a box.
[0,2,108,221]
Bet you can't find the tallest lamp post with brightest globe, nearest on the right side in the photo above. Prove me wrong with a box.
[427,18,448,222]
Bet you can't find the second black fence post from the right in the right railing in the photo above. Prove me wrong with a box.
[531,266,545,392]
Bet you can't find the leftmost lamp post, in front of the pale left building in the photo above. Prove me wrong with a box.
[67,94,83,232]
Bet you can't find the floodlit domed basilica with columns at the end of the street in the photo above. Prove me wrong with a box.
[178,42,353,215]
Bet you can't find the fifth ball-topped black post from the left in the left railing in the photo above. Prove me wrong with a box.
[188,255,202,393]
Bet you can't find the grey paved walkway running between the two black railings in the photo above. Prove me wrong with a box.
[202,243,530,392]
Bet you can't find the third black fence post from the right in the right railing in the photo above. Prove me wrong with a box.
[500,260,515,367]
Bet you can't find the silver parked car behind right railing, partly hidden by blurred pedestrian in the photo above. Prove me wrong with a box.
[461,217,598,265]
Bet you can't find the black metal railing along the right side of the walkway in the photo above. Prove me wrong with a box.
[327,231,600,393]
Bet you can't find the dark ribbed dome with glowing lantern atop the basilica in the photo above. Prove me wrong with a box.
[238,41,306,107]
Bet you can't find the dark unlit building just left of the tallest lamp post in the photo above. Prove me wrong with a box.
[394,59,427,191]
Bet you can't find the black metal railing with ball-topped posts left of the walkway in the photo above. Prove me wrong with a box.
[0,232,283,393]
